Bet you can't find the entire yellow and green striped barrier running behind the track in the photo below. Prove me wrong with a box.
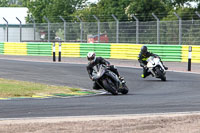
[0,42,200,63]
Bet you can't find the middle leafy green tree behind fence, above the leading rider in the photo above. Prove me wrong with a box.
[75,0,130,22]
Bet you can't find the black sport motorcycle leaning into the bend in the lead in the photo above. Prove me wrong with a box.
[92,64,129,95]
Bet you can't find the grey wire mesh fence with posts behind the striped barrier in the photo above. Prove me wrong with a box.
[0,20,200,45]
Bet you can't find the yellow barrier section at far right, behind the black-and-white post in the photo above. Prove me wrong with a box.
[181,45,200,63]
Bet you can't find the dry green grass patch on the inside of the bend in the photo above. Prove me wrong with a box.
[0,78,89,98]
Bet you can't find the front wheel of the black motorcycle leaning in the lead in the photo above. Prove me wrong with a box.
[102,78,118,95]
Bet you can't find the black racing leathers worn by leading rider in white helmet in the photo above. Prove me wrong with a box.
[87,57,120,90]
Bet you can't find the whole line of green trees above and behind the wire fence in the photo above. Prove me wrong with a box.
[0,0,200,23]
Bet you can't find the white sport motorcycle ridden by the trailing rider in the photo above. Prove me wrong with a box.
[147,56,166,81]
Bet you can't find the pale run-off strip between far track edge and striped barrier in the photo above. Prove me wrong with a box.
[0,55,200,74]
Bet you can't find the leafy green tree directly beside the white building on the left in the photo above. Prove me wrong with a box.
[23,0,86,23]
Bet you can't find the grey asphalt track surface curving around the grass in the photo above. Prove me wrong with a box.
[0,59,200,119]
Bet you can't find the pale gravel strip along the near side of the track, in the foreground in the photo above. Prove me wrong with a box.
[0,112,200,133]
